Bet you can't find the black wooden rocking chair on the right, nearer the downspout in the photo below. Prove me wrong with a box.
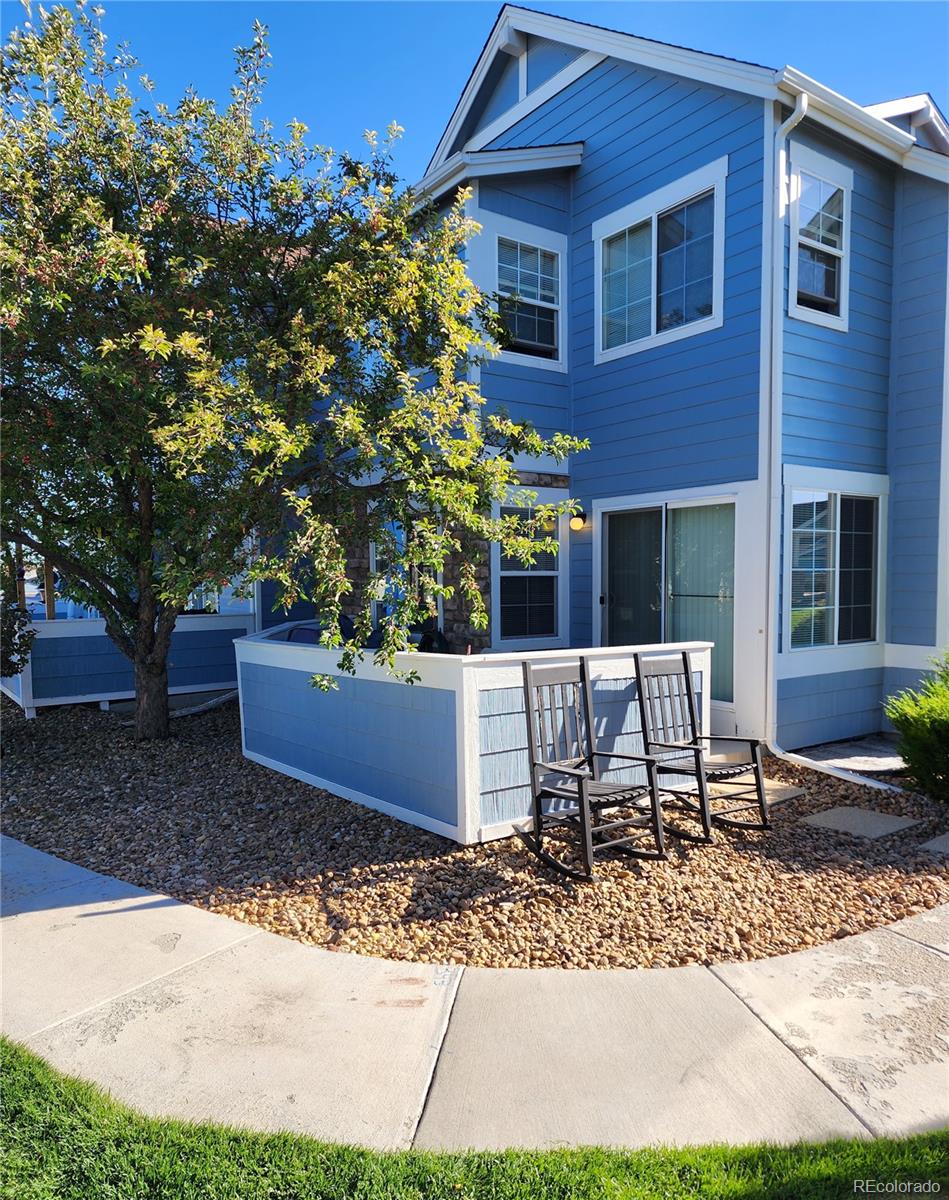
[633,650,771,841]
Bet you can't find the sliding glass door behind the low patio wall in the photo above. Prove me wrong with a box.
[605,504,734,703]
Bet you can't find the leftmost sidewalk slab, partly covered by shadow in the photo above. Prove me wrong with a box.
[2,856,258,1038]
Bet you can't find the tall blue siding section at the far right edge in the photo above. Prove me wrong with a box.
[887,172,949,646]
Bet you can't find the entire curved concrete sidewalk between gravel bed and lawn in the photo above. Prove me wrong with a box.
[0,838,949,1150]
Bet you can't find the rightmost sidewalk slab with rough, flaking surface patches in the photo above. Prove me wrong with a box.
[711,930,949,1136]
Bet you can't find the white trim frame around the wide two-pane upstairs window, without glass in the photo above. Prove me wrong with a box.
[590,155,728,364]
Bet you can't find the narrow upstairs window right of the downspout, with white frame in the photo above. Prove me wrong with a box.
[788,142,853,331]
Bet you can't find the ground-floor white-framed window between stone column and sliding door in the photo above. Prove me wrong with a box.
[491,487,569,650]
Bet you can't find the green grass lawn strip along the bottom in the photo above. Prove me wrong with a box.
[0,1040,949,1200]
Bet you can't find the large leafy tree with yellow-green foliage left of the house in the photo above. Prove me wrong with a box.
[0,5,581,738]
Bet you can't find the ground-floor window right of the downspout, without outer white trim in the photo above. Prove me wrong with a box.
[786,485,882,650]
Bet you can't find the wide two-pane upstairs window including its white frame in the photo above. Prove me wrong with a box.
[593,157,728,362]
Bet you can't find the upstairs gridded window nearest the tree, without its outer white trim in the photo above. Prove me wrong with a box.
[498,238,560,359]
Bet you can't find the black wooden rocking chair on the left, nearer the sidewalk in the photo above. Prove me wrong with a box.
[518,662,666,880]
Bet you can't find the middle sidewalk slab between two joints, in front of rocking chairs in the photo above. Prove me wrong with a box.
[415,967,866,1150]
